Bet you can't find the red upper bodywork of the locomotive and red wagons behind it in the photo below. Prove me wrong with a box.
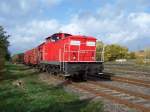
[24,33,96,65]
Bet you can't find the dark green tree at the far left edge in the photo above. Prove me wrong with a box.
[0,26,10,71]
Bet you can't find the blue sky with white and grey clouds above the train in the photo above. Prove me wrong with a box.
[0,0,150,53]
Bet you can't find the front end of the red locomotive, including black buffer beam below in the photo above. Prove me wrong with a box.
[61,35,103,79]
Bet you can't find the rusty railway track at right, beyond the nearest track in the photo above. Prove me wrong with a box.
[110,76,150,88]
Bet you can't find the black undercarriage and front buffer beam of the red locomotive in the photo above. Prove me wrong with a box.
[37,61,104,80]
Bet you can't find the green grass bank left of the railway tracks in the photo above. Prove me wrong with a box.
[0,64,103,112]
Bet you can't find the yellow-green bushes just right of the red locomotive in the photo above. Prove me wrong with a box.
[96,41,136,61]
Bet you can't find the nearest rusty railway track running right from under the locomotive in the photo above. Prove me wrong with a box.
[51,77,150,112]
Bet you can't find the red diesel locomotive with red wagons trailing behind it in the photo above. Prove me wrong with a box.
[24,33,103,79]
